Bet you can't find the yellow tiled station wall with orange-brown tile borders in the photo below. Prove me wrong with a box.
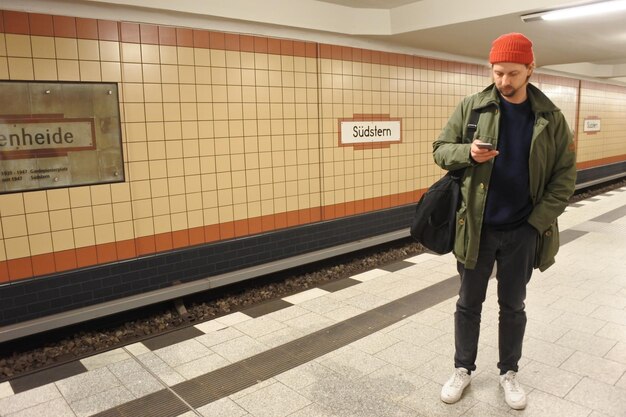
[0,11,626,284]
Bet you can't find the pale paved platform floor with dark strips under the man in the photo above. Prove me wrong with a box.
[0,187,626,417]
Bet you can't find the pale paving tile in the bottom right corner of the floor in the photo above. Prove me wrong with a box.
[565,378,626,417]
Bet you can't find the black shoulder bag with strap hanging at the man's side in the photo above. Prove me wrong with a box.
[411,110,480,255]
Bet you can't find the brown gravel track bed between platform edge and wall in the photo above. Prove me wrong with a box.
[0,180,626,382]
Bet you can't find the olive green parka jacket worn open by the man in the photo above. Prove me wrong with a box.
[433,84,576,271]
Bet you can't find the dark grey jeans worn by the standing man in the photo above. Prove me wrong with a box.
[454,223,537,374]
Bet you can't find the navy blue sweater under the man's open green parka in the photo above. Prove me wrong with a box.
[484,99,534,229]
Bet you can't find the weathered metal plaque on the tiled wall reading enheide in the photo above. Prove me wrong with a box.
[0,81,124,194]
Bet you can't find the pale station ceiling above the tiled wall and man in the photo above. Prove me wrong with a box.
[8,0,626,85]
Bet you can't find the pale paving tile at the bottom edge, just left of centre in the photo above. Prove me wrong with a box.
[235,382,311,417]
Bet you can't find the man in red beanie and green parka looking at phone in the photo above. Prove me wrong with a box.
[433,33,576,410]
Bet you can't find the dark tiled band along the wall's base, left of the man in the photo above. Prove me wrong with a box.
[0,205,414,326]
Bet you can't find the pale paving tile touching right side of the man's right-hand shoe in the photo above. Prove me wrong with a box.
[517,361,583,398]
